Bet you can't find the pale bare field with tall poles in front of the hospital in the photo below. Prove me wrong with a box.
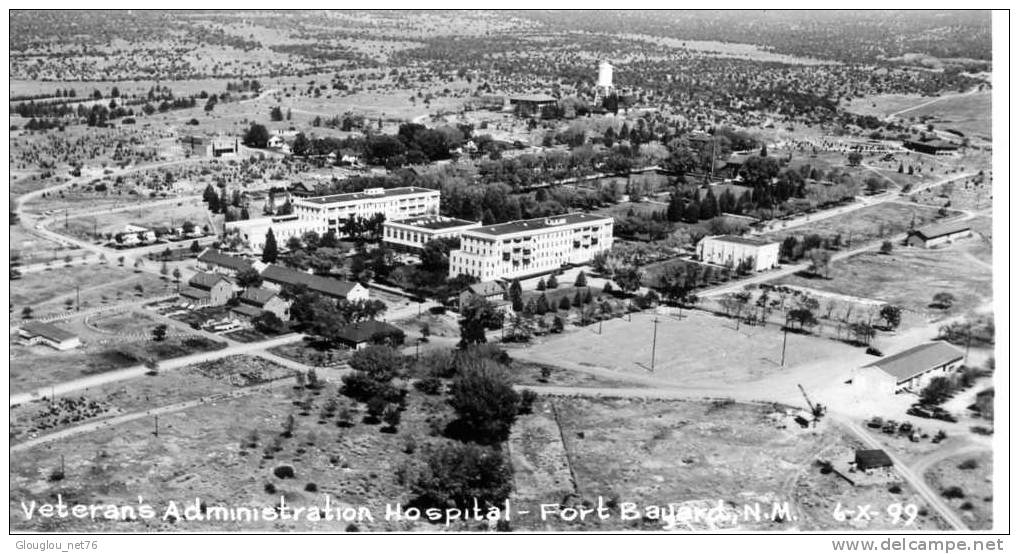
[517,311,855,385]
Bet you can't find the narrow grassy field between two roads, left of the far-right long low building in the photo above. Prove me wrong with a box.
[762,202,951,244]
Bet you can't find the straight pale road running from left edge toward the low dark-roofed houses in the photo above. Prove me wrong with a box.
[10,333,304,405]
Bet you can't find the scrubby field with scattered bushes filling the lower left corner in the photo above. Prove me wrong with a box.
[10,384,457,532]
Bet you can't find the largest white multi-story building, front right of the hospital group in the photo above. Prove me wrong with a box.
[449,213,613,281]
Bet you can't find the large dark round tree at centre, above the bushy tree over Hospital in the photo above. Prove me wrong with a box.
[449,357,520,444]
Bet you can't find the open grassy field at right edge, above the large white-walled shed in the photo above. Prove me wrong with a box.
[775,237,991,315]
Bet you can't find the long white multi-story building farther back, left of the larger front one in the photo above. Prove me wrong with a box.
[293,186,439,234]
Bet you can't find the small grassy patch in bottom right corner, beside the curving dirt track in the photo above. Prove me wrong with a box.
[923,451,994,530]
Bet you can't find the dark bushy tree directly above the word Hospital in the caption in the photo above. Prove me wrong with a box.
[411,442,513,510]
